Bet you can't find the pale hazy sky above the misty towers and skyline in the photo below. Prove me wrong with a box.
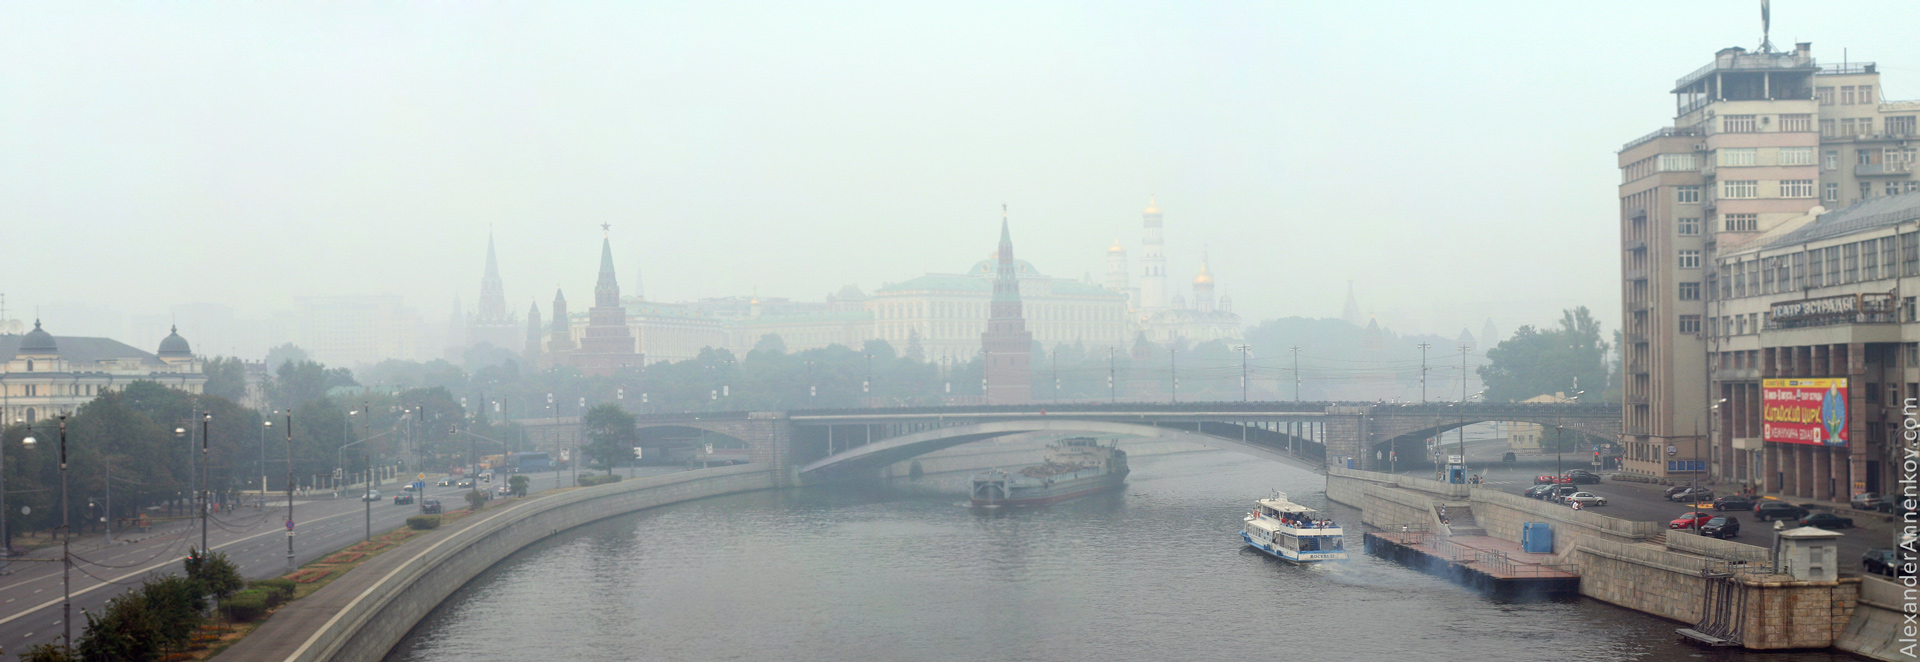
[0,0,1920,332]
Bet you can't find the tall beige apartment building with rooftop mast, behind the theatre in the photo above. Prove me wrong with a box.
[1619,42,1914,478]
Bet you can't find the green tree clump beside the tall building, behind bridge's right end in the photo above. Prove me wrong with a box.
[1480,307,1609,401]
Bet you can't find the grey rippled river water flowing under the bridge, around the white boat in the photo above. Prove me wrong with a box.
[386,445,1859,662]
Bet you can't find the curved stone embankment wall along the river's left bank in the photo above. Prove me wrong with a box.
[288,464,780,662]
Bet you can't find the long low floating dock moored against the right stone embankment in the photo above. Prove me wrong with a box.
[1365,532,1580,601]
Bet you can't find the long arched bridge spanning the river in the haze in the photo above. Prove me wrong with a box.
[606,401,1620,478]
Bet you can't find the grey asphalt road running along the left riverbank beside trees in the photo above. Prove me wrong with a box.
[0,474,487,654]
